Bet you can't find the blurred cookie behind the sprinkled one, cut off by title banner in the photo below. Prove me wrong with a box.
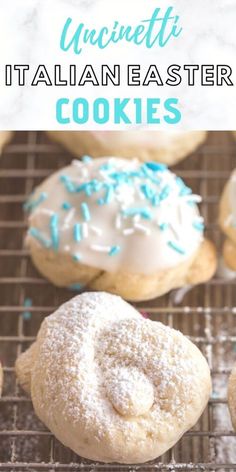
[48,128,207,165]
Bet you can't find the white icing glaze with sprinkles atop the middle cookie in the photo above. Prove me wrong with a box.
[24,158,203,274]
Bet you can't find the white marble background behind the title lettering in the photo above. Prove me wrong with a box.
[0,0,236,130]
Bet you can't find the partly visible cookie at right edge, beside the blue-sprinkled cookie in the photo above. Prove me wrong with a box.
[219,169,236,271]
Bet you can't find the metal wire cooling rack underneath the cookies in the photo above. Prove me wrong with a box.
[0,132,236,472]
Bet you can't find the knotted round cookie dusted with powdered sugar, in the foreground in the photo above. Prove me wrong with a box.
[16,292,211,464]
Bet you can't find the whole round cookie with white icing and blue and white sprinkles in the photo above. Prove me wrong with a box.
[25,157,216,301]
